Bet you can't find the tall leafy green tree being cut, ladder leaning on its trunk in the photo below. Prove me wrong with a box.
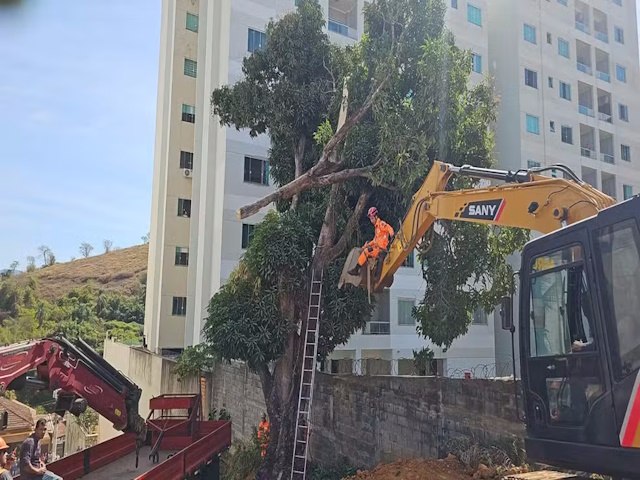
[204,0,528,478]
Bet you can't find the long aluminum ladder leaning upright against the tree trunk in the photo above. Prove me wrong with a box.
[291,269,323,480]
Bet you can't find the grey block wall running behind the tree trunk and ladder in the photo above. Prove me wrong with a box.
[212,363,524,467]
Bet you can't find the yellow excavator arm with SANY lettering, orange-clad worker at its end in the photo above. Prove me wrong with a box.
[341,161,615,292]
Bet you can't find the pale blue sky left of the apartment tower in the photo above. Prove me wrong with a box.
[0,0,161,270]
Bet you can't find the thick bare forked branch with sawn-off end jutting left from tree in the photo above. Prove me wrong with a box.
[236,74,390,220]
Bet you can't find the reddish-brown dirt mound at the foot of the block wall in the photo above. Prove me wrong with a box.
[343,457,473,480]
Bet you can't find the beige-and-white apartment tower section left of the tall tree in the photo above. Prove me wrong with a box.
[144,0,376,355]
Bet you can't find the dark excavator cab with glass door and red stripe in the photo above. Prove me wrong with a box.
[510,197,640,478]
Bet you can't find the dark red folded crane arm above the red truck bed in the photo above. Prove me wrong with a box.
[0,337,145,437]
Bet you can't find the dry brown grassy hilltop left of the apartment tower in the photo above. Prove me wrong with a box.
[17,244,149,300]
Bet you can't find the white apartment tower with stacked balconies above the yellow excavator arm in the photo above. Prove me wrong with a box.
[488,0,640,370]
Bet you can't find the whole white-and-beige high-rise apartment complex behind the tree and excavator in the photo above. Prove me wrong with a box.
[145,0,640,376]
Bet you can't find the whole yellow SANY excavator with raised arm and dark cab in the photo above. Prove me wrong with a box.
[339,162,640,479]
